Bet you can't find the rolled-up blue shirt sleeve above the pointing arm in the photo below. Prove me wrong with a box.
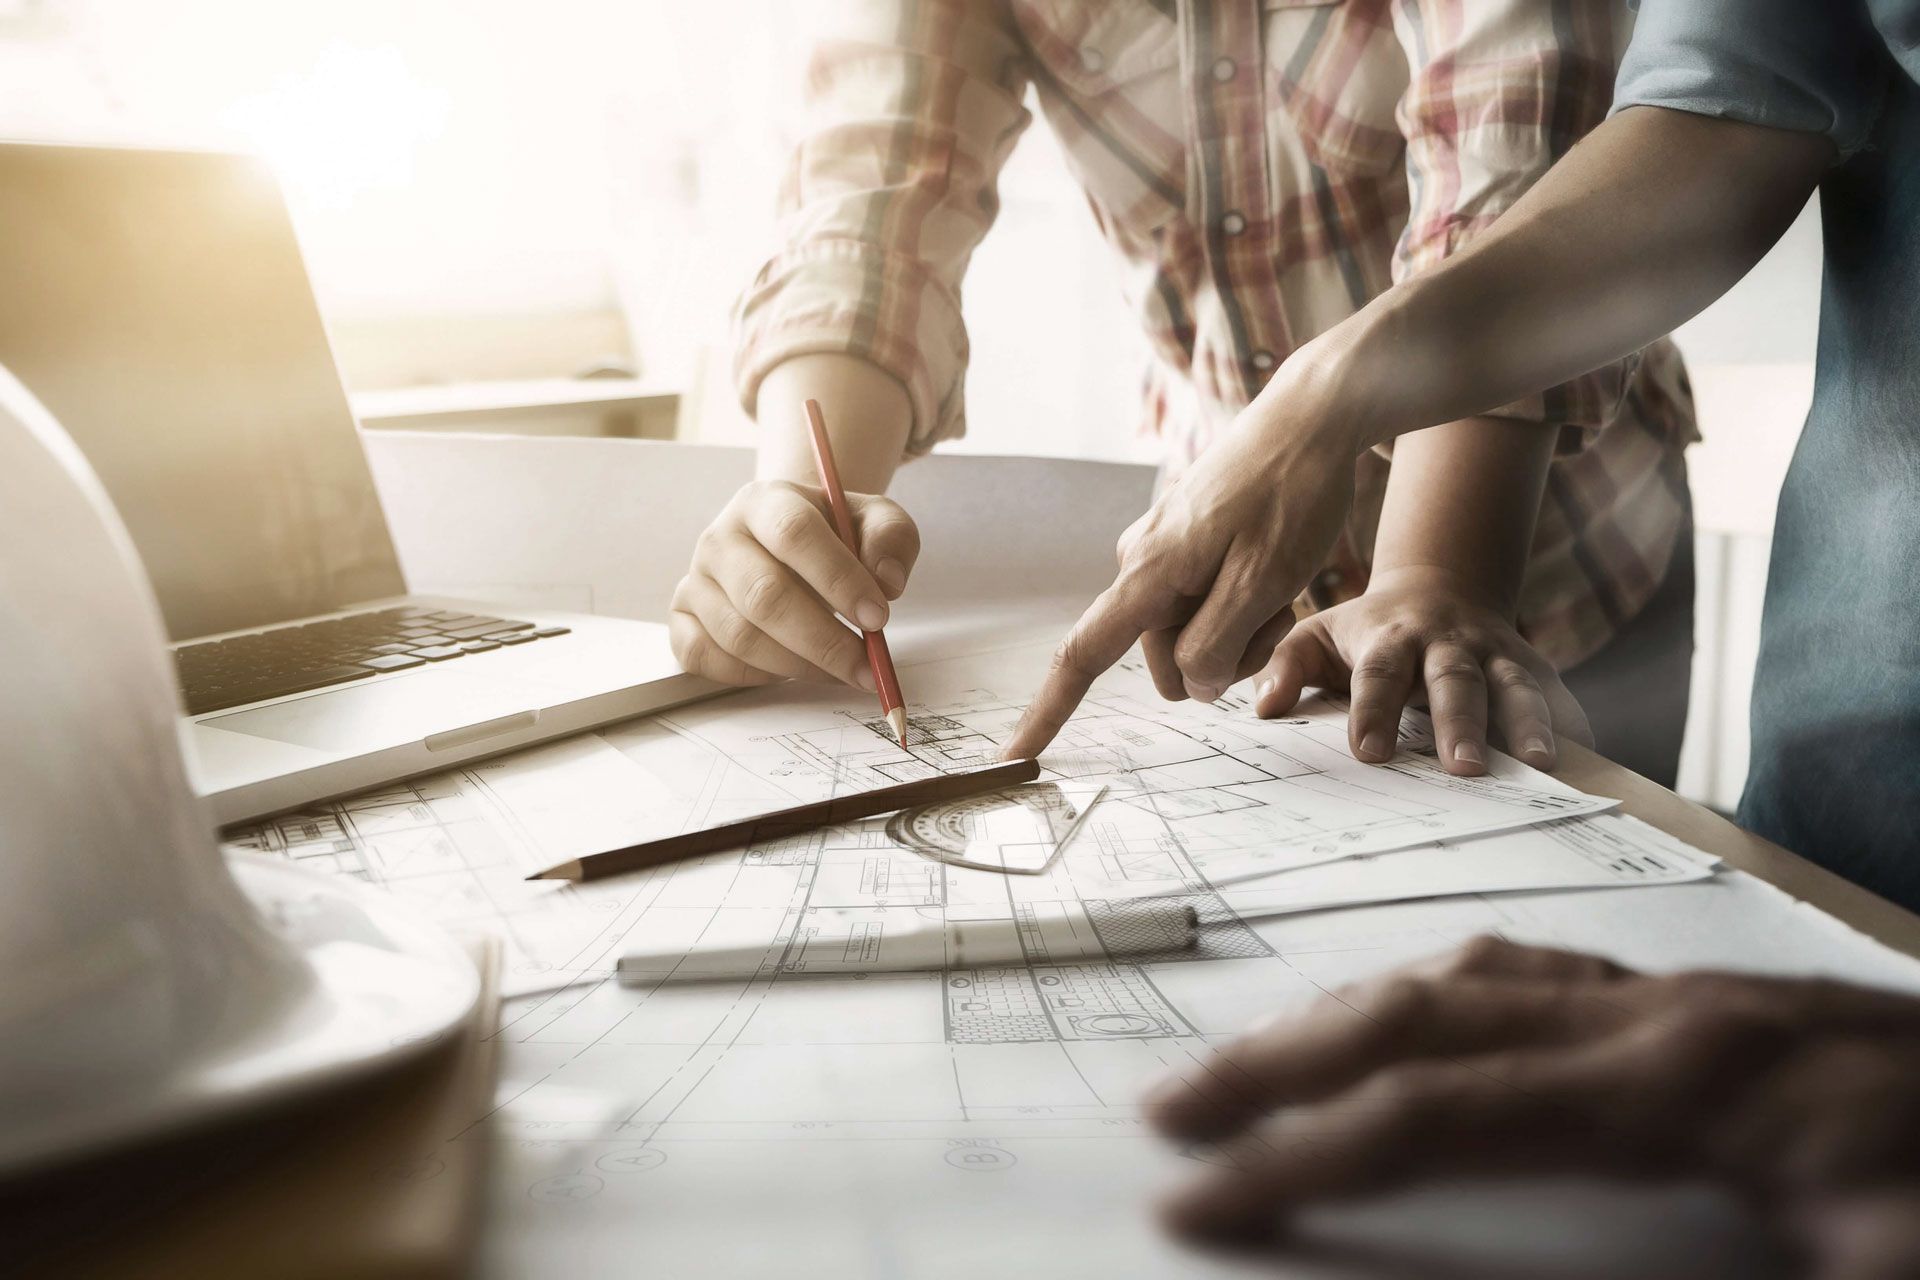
[1613,0,1885,157]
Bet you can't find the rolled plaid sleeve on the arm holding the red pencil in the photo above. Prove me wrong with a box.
[735,0,1029,455]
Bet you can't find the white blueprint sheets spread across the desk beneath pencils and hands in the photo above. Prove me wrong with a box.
[217,637,1920,1280]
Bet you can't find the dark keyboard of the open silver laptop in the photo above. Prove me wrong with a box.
[173,608,568,716]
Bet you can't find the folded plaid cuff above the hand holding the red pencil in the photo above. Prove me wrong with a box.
[733,240,968,457]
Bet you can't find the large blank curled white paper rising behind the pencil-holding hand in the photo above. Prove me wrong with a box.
[365,432,1154,640]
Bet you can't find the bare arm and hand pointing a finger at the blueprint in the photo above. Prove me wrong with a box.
[1008,107,1834,756]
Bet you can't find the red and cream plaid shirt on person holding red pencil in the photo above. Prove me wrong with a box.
[737,0,1695,668]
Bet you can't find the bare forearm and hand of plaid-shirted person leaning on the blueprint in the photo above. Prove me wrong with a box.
[1254,418,1592,775]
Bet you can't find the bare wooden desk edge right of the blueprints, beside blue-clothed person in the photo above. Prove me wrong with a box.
[1553,745,1920,956]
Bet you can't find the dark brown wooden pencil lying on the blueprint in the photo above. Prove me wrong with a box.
[526,760,1041,881]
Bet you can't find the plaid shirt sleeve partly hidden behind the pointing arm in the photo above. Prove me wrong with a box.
[1392,0,1640,447]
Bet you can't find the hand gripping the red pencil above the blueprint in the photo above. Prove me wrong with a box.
[668,480,920,691]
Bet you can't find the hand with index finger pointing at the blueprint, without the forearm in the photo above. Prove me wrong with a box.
[1006,416,1356,758]
